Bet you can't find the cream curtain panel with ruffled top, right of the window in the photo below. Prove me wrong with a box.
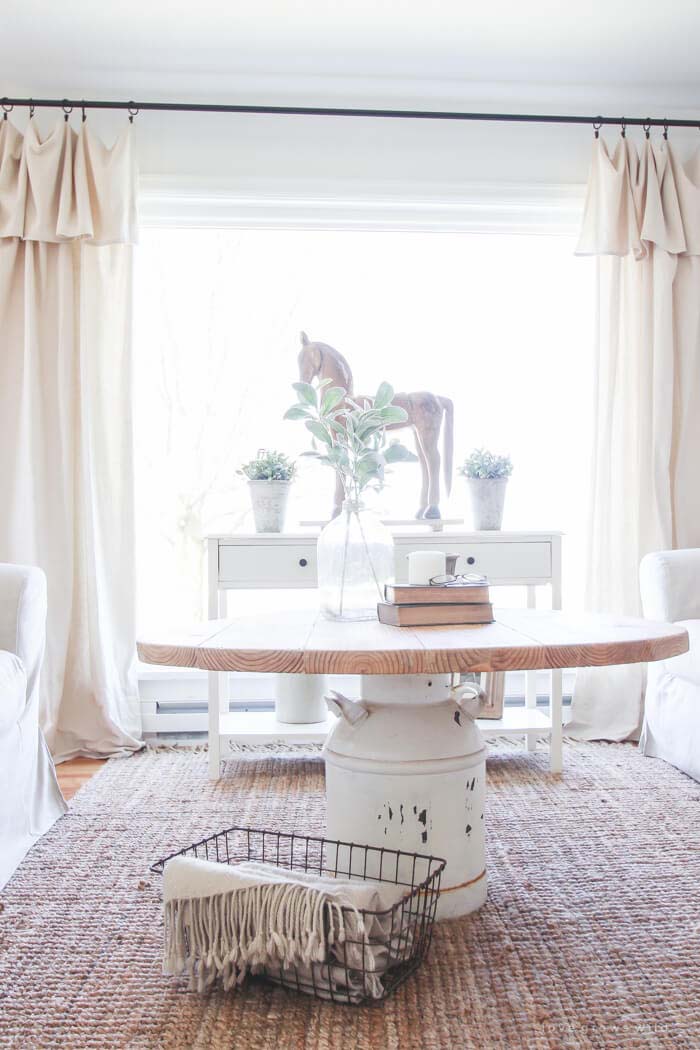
[569,138,700,740]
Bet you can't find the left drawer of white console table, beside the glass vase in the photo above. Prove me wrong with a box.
[218,540,316,588]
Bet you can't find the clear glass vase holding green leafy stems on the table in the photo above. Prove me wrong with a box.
[318,500,394,620]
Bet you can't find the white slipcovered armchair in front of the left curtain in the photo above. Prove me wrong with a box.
[0,565,66,888]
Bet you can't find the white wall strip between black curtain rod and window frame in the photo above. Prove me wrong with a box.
[136,107,592,185]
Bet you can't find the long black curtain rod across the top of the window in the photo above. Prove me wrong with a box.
[0,98,700,128]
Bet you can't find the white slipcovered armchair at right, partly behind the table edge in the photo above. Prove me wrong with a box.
[639,548,700,780]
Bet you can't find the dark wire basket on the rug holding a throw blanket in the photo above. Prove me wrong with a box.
[151,827,445,1005]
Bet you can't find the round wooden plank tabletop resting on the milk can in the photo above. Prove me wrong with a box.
[137,609,688,674]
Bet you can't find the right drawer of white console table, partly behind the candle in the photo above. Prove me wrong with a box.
[397,538,552,583]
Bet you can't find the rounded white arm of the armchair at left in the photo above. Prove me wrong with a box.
[0,564,46,702]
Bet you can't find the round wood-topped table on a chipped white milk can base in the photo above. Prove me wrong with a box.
[139,609,688,918]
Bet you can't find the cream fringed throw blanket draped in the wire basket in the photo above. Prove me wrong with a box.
[163,857,407,1002]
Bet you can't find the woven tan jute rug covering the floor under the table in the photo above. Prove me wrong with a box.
[0,744,700,1050]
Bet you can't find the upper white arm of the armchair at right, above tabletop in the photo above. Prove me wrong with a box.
[639,547,700,623]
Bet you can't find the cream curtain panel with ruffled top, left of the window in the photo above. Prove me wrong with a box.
[0,120,141,760]
